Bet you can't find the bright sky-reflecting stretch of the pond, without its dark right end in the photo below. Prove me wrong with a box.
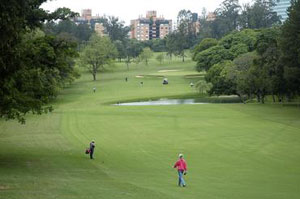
[114,99,208,106]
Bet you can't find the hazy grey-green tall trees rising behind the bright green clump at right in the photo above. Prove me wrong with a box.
[198,0,280,40]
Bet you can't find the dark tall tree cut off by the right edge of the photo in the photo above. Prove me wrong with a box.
[280,0,300,97]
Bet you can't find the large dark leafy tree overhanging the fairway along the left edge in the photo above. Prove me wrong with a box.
[0,0,76,122]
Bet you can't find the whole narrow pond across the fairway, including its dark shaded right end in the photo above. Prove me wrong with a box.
[113,99,240,106]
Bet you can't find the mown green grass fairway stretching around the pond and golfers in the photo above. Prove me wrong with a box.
[0,59,300,199]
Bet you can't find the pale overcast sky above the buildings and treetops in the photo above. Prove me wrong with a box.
[42,0,251,25]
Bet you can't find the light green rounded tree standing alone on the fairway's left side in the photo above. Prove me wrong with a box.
[80,34,118,81]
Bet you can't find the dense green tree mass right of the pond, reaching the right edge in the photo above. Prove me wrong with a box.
[193,0,300,103]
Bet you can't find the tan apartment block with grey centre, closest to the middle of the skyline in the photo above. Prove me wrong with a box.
[130,11,172,41]
